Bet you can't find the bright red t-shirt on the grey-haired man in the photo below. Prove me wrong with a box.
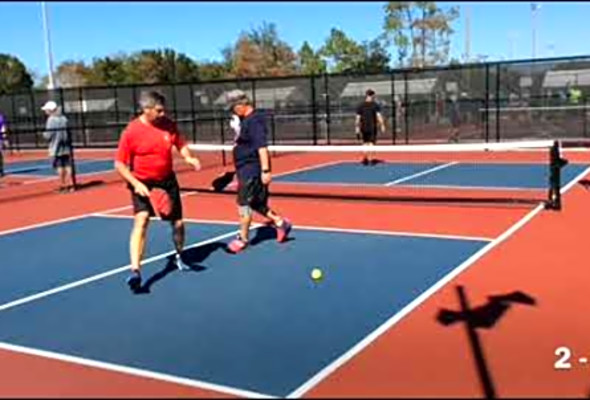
[116,118,185,181]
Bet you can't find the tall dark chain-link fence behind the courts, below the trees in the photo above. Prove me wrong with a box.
[0,56,590,149]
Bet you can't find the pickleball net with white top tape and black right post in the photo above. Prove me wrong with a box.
[184,141,587,209]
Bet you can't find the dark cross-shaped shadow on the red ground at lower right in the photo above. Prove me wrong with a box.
[436,286,537,398]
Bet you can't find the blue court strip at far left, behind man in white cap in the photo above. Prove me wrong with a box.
[4,159,114,177]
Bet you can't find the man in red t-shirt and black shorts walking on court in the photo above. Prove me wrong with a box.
[115,91,200,291]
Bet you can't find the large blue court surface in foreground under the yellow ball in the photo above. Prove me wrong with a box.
[0,216,489,397]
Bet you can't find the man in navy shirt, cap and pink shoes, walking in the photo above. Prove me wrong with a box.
[226,90,292,253]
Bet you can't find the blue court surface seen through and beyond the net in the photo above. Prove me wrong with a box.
[274,162,588,190]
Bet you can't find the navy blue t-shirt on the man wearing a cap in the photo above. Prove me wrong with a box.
[233,110,267,181]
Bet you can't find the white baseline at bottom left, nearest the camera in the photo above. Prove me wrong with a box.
[0,342,275,399]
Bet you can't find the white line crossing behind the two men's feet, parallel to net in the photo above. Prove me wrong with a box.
[94,213,494,242]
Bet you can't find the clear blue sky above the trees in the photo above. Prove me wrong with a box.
[0,2,590,81]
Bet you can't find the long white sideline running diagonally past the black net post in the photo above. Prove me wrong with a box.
[287,163,590,398]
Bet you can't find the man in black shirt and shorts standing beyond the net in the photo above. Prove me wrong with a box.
[355,89,385,165]
